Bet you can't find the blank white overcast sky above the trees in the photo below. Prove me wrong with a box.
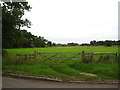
[23,0,119,44]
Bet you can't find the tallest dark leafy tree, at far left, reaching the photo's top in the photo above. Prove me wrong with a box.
[2,2,31,48]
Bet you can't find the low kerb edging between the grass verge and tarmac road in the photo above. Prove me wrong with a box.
[2,72,120,84]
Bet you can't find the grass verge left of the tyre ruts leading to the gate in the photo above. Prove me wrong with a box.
[3,64,69,79]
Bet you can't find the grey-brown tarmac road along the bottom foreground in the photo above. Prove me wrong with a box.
[2,77,118,88]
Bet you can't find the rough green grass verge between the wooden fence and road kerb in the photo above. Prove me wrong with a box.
[3,62,118,80]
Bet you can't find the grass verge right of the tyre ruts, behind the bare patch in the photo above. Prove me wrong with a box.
[69,63,118,79]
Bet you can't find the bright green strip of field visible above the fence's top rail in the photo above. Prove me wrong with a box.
[6,46,118,54]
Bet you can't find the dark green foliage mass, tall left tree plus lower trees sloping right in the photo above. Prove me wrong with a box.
[2,2,47,48]
